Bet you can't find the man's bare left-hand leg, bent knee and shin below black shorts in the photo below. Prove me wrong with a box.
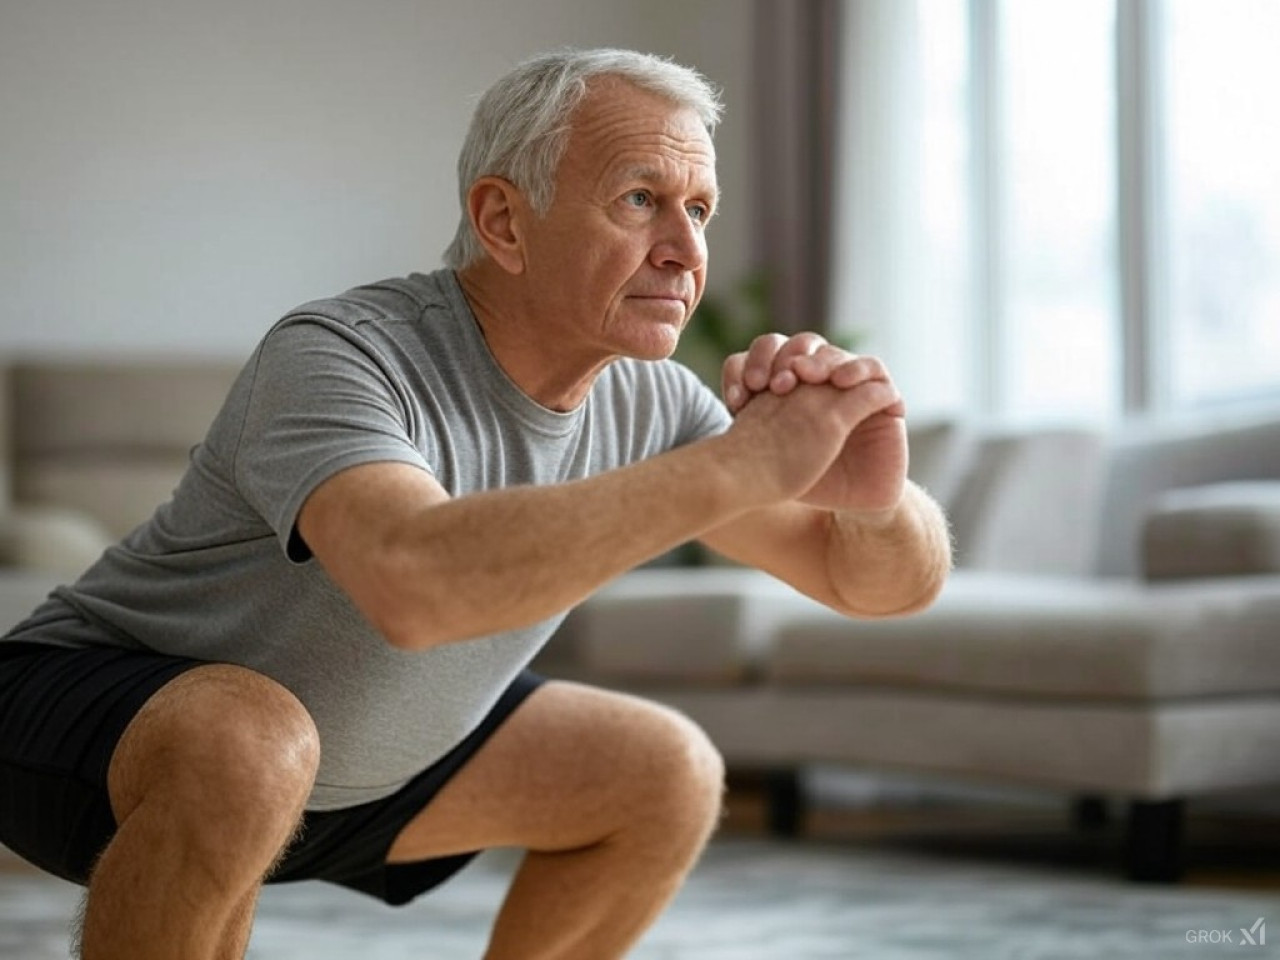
[82,666,319,960]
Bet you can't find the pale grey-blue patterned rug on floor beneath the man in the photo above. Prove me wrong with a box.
[0,837,1280,960]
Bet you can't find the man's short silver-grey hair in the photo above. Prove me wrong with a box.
[444,49,722,270]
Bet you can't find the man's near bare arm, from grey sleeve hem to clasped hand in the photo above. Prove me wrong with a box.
[297,371,896,649]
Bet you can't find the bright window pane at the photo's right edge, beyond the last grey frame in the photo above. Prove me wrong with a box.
[1164,0,1280,404]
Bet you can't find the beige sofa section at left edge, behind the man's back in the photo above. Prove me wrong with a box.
[0,357,239,628]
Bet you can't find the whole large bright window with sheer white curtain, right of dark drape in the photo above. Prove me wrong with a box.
[836,0,1280,420]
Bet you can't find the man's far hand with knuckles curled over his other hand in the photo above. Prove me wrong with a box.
[722,333,908,513]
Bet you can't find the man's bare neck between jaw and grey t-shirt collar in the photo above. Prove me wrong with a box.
[457,264,613,412]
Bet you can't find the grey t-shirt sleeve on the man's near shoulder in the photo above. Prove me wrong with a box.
[233,317,431,563]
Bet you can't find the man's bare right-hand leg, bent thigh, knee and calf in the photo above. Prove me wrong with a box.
[388,682,723,960]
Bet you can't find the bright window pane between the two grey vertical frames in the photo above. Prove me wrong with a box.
[996,0,1117,416]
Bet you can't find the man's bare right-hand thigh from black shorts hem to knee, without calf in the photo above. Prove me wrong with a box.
[388,681,723,863]
